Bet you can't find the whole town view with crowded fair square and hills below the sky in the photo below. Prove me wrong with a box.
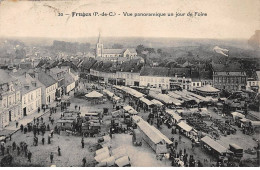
[0,30,260,167]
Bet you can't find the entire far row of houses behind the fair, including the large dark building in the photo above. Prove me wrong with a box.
[88,61,260,92]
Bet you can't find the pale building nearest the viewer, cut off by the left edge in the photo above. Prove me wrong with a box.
[0,69,22,129]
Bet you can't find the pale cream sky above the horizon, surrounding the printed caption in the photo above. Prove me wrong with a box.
[0,0,260,39]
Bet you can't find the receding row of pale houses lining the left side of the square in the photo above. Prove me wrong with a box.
[0,67,78,129]
